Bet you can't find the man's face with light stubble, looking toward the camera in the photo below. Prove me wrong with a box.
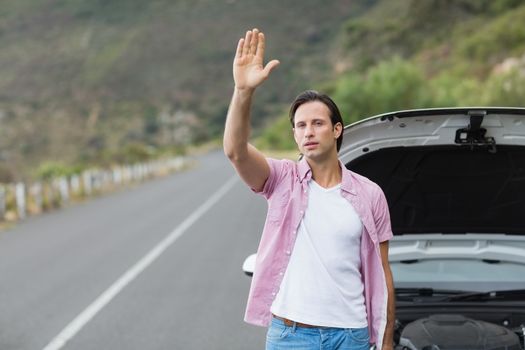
[293,101,343,160]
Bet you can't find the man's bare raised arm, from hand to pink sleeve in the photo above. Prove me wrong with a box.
[223,29,279,191]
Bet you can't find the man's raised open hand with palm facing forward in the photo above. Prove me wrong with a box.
[233,29,279,90]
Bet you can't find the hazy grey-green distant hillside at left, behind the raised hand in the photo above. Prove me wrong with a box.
[0,0,373,182]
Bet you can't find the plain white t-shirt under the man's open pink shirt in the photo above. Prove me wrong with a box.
[271,180,367,328]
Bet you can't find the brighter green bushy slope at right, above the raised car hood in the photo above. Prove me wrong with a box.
[259,0,525,147]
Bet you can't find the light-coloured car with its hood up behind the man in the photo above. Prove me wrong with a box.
[243,107,525,350]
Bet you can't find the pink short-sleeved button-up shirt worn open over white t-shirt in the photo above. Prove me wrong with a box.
[245,158,393,348]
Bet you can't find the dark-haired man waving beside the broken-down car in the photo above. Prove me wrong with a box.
[224,29,395,350]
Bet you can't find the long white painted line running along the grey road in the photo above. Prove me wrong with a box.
[44,176,237,350]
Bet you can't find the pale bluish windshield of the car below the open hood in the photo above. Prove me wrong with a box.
[390,259,525,292]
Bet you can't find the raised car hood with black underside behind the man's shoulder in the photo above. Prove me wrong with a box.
[339,108,525,235]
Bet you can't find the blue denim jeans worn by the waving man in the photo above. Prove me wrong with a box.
[266,317,370,350]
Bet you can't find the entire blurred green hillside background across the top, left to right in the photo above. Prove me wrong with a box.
[0,0,525,182]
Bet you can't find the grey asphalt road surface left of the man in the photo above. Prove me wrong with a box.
[0,152,266,350]
